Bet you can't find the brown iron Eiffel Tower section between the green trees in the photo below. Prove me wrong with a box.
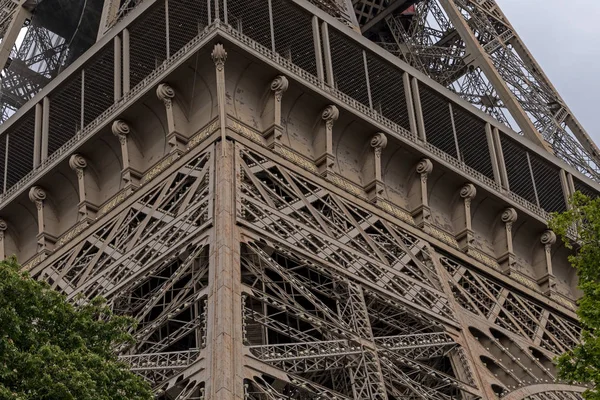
[0,0,600,400]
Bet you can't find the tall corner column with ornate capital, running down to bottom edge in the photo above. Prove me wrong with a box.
[206,44,244,400]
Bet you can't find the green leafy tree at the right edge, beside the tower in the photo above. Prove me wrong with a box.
[550,192,600,400]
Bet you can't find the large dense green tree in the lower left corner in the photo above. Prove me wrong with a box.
[0,259,152,400]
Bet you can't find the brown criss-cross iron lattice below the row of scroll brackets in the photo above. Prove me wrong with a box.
[25,137,581,400]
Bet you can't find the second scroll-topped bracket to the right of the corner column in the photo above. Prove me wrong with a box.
[313,105,340,176]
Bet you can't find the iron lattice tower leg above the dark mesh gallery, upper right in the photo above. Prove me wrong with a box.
[353,0,600,180]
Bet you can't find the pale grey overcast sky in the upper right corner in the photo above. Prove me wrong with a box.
[496,0,600,146]
